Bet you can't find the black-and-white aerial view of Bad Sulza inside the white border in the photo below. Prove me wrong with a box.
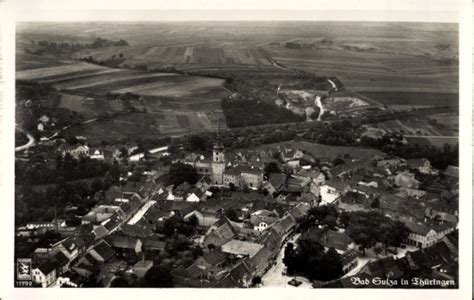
[13,20,460,289]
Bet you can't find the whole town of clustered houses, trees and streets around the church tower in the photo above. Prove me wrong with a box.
[16,125,459,288]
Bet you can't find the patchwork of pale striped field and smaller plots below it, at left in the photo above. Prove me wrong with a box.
[17,60,229,144]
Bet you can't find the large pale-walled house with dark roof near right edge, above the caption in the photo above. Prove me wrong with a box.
[405,222,456,249]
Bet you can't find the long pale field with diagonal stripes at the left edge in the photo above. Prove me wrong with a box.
[17,62,229,100]
